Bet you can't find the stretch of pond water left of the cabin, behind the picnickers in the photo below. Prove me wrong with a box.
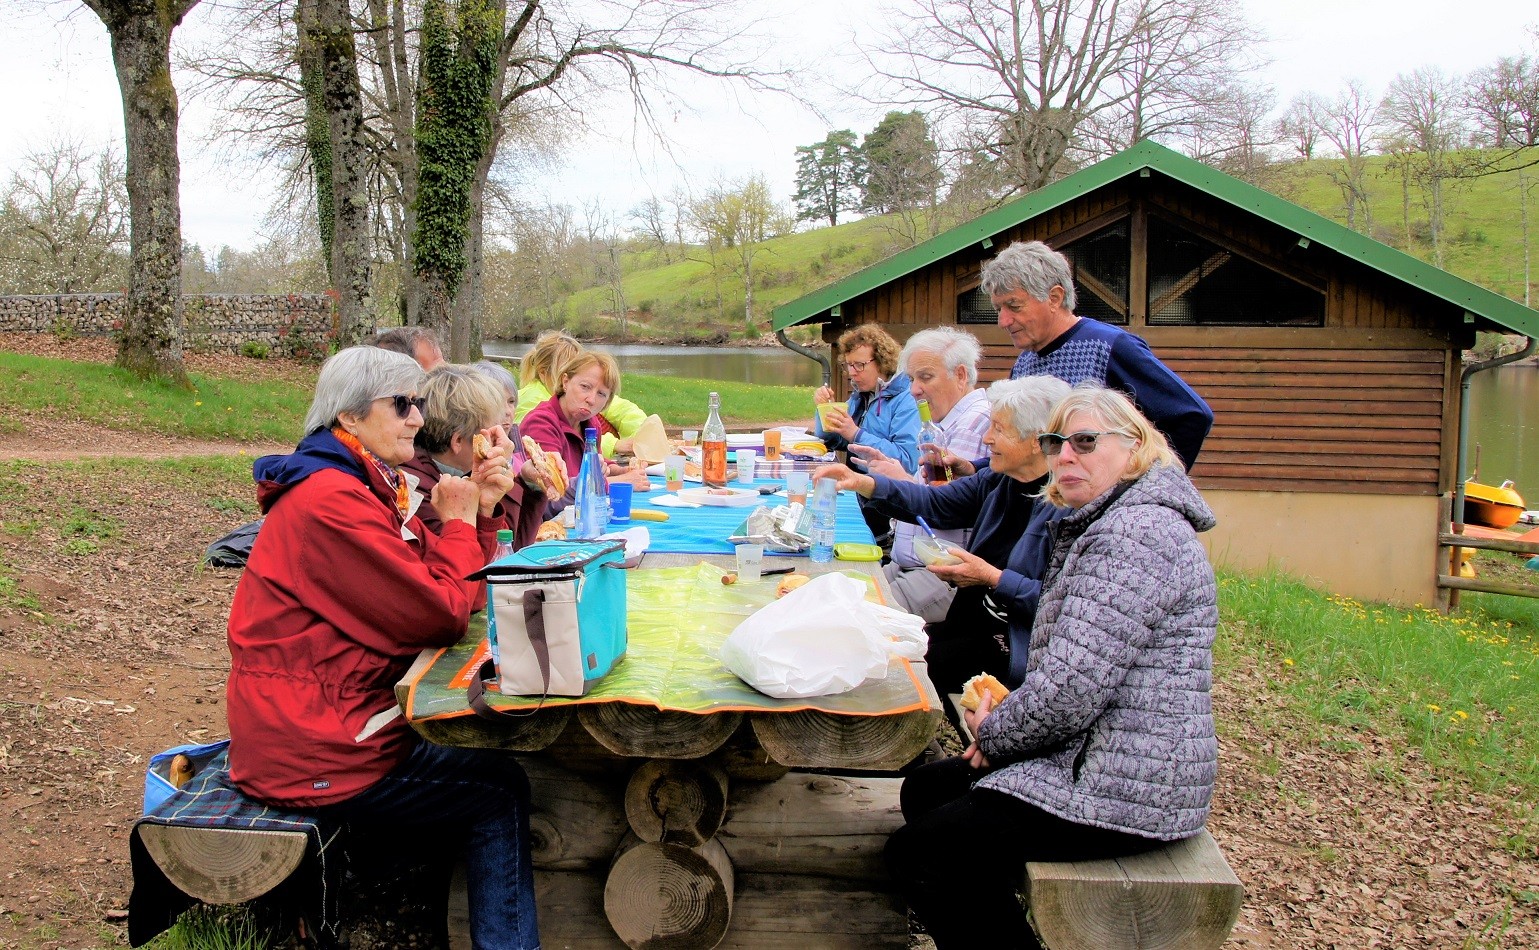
[482,340,823,388]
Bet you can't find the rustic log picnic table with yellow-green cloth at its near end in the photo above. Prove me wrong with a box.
[397,480,940,948]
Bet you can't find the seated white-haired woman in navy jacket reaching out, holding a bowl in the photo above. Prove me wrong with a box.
[814,376,1070,708]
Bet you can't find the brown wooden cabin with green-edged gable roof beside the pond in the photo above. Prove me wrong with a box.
[773,142,1539,604]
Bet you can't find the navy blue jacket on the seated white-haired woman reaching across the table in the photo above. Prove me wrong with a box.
[870,467,1070,688]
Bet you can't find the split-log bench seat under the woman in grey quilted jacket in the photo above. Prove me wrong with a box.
[948,693,1245,950]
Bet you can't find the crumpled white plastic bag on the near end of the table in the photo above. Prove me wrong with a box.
[722,574,930,699]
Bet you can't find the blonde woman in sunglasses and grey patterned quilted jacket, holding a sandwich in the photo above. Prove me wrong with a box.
[886,383,1219,950]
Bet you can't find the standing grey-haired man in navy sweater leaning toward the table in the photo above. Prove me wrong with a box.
[983,240,1213,470]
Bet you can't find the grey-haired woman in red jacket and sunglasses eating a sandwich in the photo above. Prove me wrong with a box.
[226,346,539,948]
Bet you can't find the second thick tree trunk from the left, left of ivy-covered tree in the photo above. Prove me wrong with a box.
[300,0,374,346]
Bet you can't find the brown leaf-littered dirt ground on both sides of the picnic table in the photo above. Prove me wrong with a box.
[0,336,1539,950]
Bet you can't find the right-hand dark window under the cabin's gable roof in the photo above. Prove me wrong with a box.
[1148,214,1325,326]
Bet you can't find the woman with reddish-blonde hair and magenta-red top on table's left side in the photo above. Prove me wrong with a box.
[519,350,653,491]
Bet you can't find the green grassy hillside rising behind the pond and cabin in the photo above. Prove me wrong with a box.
[523,146,1539,340]
